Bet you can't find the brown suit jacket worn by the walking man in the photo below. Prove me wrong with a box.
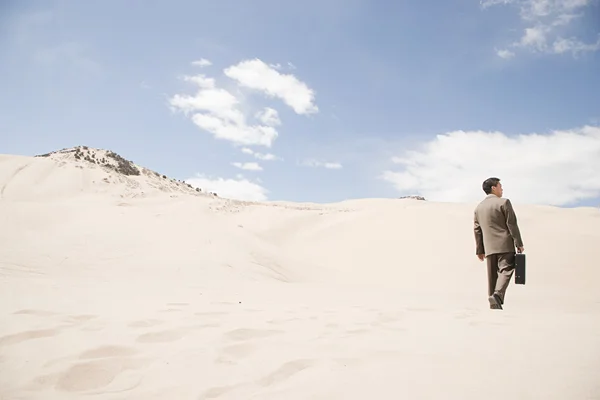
[474,194,523,257]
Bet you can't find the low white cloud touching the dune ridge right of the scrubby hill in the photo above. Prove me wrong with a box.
[186,174,269,201]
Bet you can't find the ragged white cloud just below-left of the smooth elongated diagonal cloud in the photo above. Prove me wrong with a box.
[169,74,278,147]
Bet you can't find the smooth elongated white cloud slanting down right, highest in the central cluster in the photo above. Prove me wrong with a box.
[224,59,319,114]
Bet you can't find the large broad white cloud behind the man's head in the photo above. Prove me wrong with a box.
[381,126,600,206]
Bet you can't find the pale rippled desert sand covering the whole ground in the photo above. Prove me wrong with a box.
[0,149,600,400]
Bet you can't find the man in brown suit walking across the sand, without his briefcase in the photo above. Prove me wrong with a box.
[474,178,524,310]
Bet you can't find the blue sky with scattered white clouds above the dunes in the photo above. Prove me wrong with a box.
[0,0,600,207]
